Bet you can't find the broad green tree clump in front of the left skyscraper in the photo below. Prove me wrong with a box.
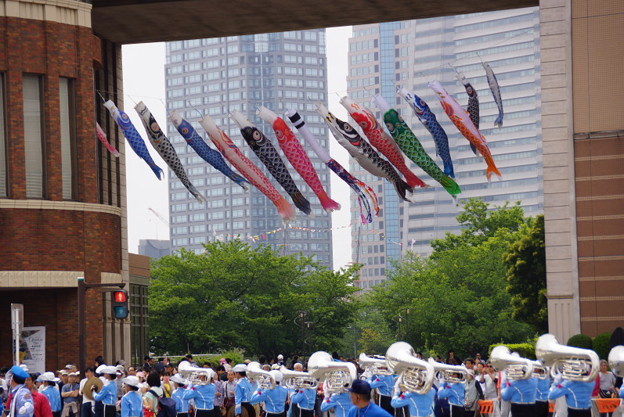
[149,240,356,355]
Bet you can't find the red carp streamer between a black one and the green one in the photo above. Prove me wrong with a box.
[340,96,427,188]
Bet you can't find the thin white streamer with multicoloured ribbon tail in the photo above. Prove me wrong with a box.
[286,110,379,224]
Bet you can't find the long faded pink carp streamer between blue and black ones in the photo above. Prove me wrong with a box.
[199,112,296,222]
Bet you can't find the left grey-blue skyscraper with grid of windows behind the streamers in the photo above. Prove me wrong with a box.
[166,29,332,267]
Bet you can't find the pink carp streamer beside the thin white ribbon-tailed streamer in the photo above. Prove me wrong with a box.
[256,107,340,213]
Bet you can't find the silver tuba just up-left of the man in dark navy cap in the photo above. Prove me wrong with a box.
[308,350,357,394]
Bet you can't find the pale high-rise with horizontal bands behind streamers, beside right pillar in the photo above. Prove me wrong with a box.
[347,8,543,289]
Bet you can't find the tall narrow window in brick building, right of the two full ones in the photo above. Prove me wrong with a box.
[59,77,78,200]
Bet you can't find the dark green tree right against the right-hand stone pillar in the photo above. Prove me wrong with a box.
[503,215,548,333]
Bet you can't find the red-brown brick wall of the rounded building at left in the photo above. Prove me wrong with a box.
[0,13,125,370]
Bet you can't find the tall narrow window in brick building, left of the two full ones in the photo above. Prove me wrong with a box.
[23,74,45,198]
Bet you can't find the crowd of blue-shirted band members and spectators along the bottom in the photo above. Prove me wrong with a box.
[0,351,624,417]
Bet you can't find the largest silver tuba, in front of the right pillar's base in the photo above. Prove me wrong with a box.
[535,334,600,382]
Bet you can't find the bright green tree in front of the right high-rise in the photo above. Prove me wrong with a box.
[364,200,533,355]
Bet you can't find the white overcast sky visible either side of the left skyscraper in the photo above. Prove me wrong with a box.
[120,26,351,269]
